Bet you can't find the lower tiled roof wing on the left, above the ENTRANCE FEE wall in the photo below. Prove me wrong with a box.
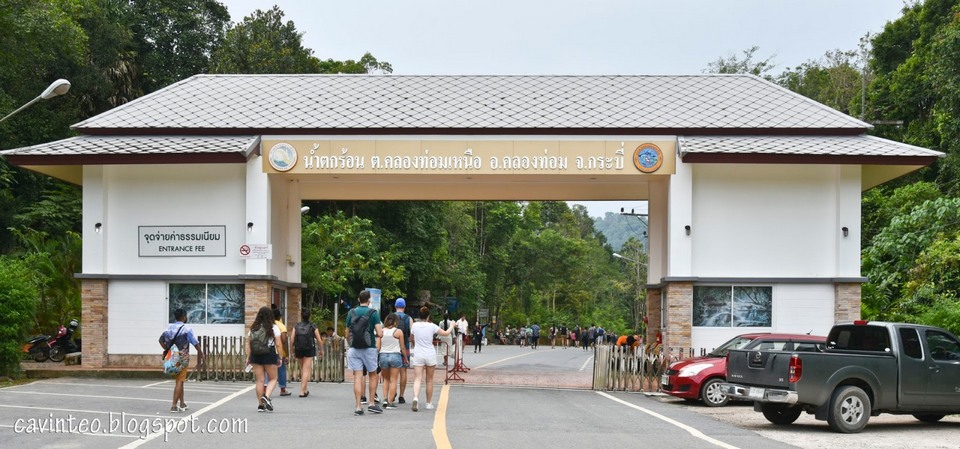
[0,136,260,156]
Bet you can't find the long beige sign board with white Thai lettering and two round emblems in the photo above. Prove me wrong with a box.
[261,138,676,175]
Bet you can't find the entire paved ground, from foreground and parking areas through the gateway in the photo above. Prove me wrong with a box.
[0,346,960,449]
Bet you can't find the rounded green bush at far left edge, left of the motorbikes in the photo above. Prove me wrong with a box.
[0,257,39,377]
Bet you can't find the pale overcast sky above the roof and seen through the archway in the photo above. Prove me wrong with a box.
[220,0,904,217]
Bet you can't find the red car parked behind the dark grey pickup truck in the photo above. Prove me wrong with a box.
[660,333,827,407]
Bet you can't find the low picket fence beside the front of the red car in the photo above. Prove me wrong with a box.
[593,345,706,392]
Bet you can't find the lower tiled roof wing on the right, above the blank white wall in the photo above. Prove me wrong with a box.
[679,135,944,157]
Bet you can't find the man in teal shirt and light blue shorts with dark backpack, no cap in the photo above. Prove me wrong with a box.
[346,290,383,416]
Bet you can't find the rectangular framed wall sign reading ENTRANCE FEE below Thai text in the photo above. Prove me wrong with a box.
[137,225,227,257]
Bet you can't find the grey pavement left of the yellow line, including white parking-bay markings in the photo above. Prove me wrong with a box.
[0,376,442,449]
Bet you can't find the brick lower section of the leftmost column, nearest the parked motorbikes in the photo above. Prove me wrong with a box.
[80,279,108,368]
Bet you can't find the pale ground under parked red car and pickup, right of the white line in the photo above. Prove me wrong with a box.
[661,397,960,449]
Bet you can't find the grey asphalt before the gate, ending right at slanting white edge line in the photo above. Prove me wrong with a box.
[0,378,790,449]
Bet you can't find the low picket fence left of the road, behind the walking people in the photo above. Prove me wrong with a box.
[191,336,345,382]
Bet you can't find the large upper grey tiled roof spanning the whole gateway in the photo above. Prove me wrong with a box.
[75,75,870,134]
